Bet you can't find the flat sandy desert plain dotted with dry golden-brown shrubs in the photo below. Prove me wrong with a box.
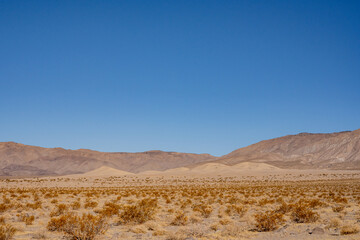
[0,173,360,240]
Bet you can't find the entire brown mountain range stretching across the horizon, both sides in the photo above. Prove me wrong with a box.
[0,129,360,176]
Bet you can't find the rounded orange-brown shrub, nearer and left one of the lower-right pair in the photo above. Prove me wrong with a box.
[254,211,284,232]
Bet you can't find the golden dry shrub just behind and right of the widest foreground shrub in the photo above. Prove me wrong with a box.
[119,198,157,224]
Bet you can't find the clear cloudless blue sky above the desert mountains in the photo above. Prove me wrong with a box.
[0,0,360,155]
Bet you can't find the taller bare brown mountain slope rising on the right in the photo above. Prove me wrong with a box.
[216,129,360,170]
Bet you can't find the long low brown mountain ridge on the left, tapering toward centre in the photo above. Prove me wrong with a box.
[0,142,216,176]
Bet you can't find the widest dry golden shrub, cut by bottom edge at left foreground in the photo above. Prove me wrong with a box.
[47,213,107,240]
